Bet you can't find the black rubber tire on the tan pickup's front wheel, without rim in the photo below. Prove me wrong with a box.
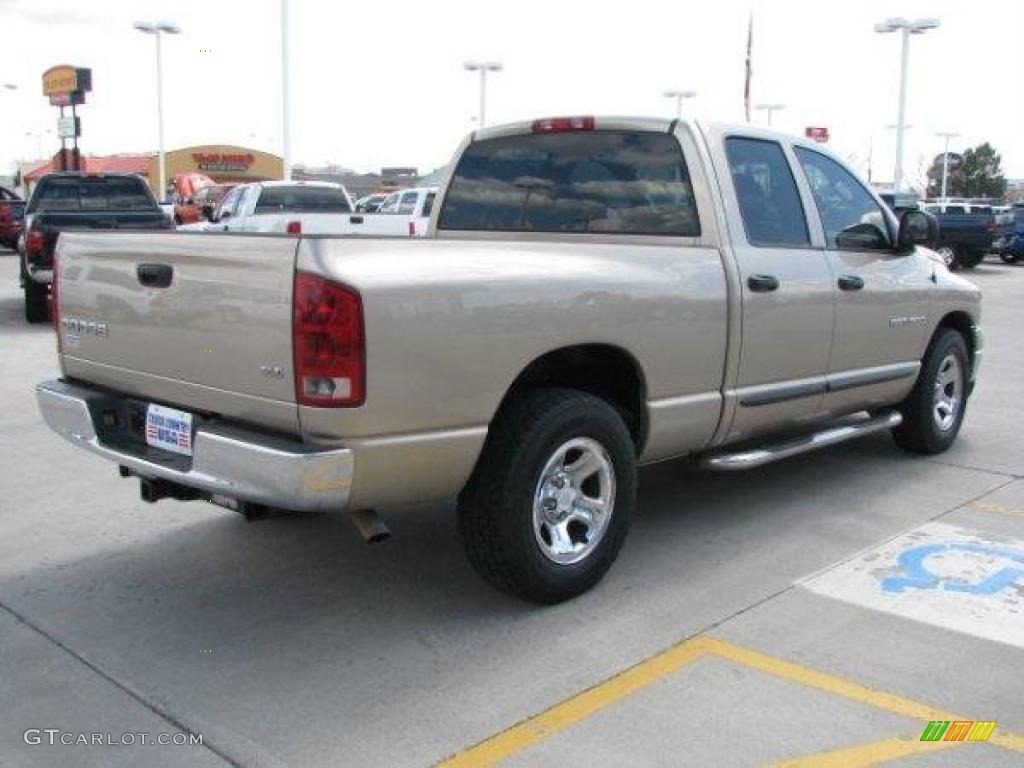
[893,328,971,455]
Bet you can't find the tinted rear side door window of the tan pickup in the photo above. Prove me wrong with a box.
[725,136,811,247]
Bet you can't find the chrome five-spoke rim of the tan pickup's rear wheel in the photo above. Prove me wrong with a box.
[534,437,615,565]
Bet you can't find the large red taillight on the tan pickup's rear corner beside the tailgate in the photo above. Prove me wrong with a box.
[292,272,367,408]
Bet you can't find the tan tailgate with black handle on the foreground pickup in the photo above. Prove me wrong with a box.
[57,232,298,432]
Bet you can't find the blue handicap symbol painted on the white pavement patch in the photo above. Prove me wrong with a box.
[882,542,1024,595]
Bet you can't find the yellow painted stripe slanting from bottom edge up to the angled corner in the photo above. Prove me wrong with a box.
[439,637,707,768]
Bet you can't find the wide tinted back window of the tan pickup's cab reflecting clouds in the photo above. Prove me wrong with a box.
[438,131,700,237]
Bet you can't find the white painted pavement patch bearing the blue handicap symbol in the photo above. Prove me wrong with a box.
[799,522,1024,648]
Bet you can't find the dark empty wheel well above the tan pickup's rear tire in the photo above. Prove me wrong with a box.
[496,344,647,456]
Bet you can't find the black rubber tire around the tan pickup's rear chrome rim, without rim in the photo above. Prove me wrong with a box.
[459,388,636,604]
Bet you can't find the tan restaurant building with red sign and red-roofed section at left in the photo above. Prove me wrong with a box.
[23,144,285,198]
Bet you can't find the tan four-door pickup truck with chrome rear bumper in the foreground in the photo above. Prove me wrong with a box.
[38,117,982,602]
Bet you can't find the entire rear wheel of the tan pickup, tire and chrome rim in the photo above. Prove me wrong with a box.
[459,388,636,603]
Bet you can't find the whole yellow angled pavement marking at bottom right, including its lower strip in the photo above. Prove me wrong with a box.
[438,635,1024,768]
